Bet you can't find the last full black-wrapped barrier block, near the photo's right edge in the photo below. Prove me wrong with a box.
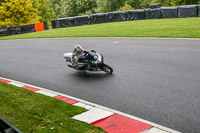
[178,5,198,18]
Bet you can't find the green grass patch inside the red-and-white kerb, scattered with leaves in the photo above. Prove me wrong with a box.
[0,83,104,133]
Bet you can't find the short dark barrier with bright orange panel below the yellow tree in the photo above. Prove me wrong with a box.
[0,22,48,36]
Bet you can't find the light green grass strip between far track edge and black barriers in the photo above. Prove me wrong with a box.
[0,17,200,40]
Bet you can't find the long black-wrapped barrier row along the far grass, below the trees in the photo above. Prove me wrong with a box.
[51,3,200,28]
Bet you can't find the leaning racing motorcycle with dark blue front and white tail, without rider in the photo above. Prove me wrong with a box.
[63,50,113,74]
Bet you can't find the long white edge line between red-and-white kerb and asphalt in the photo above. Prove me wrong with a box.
[0,77,181,133]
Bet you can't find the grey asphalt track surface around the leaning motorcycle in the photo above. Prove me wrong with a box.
[0,38,200,133]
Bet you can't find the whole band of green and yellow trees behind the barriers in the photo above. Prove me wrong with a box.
[0,0,200,27]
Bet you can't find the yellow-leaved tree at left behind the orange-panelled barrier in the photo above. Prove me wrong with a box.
[0,0,40,27]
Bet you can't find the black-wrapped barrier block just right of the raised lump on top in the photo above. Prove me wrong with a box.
[161,7,178,18]
